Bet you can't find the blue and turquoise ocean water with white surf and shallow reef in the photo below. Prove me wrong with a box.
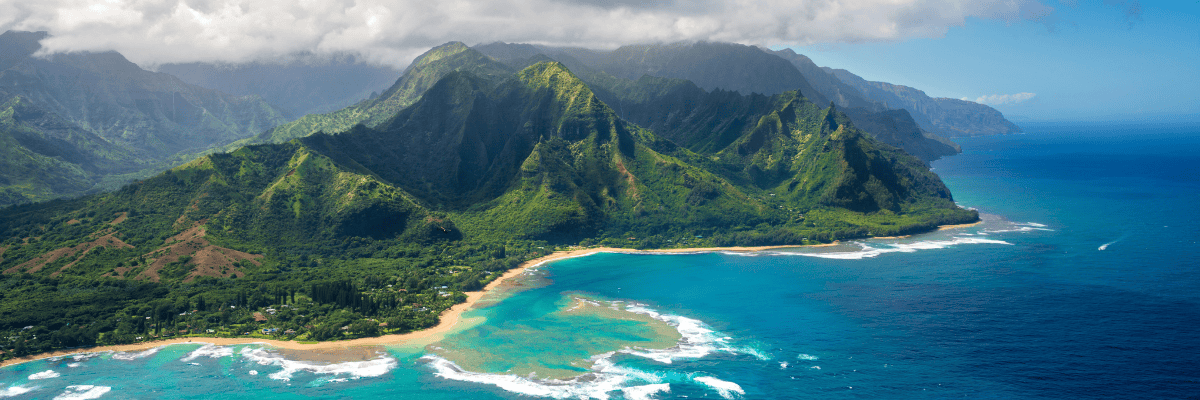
[0,124,1200,399]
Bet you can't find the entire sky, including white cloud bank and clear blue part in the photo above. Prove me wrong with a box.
[0,0,1200,120]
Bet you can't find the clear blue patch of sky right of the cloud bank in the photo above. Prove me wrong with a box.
[796,0,1200,123]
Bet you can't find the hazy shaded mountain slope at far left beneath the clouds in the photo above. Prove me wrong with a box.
[0,31,283,205]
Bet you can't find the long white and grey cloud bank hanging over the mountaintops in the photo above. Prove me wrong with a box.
[0,0,1054,66]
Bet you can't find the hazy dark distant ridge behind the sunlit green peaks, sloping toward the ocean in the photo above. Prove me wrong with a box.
[475,42,959,161]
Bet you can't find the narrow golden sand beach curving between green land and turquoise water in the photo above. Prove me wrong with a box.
[0,221,969,368]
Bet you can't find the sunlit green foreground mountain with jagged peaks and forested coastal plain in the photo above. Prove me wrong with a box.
[0,46,978,357]
